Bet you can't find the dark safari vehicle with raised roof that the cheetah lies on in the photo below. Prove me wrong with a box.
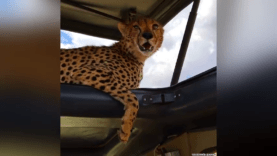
[61,0,216,156]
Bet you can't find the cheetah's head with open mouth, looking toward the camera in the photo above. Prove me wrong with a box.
[118,18,164,57]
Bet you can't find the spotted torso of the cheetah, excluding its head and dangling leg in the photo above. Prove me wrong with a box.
[60,46,143,89]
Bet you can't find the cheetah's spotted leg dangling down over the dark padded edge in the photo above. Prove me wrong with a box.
[73,67,139,143]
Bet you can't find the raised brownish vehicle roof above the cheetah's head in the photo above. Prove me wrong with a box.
[61,0,193,40]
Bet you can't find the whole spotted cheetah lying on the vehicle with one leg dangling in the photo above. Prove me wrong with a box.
[60,17,164,143]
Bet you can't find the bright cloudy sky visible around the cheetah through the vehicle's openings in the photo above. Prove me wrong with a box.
[61,0,217,88]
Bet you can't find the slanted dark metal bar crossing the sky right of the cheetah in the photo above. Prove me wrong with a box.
[170,0,200,86]
